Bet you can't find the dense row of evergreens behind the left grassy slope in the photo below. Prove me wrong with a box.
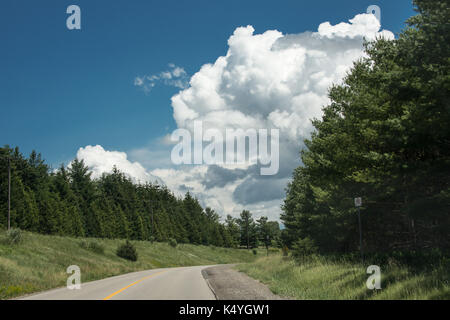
[0,146,279,247]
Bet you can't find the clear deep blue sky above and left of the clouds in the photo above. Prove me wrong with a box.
[0,0,413,165]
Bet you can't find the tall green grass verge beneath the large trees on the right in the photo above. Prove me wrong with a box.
[237,254,450,300]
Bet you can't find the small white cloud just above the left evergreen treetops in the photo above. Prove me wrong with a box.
[77,145,162,184]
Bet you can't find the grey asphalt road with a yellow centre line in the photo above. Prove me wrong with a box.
[22,266,215,300]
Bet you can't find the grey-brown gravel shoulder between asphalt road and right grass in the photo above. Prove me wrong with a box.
[202,265,283,300]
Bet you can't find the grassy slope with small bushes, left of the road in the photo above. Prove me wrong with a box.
[0,231,255,299]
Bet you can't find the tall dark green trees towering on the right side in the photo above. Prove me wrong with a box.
[281,0,450,252]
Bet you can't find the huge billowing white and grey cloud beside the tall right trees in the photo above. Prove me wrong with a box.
[158,14,394,218]
